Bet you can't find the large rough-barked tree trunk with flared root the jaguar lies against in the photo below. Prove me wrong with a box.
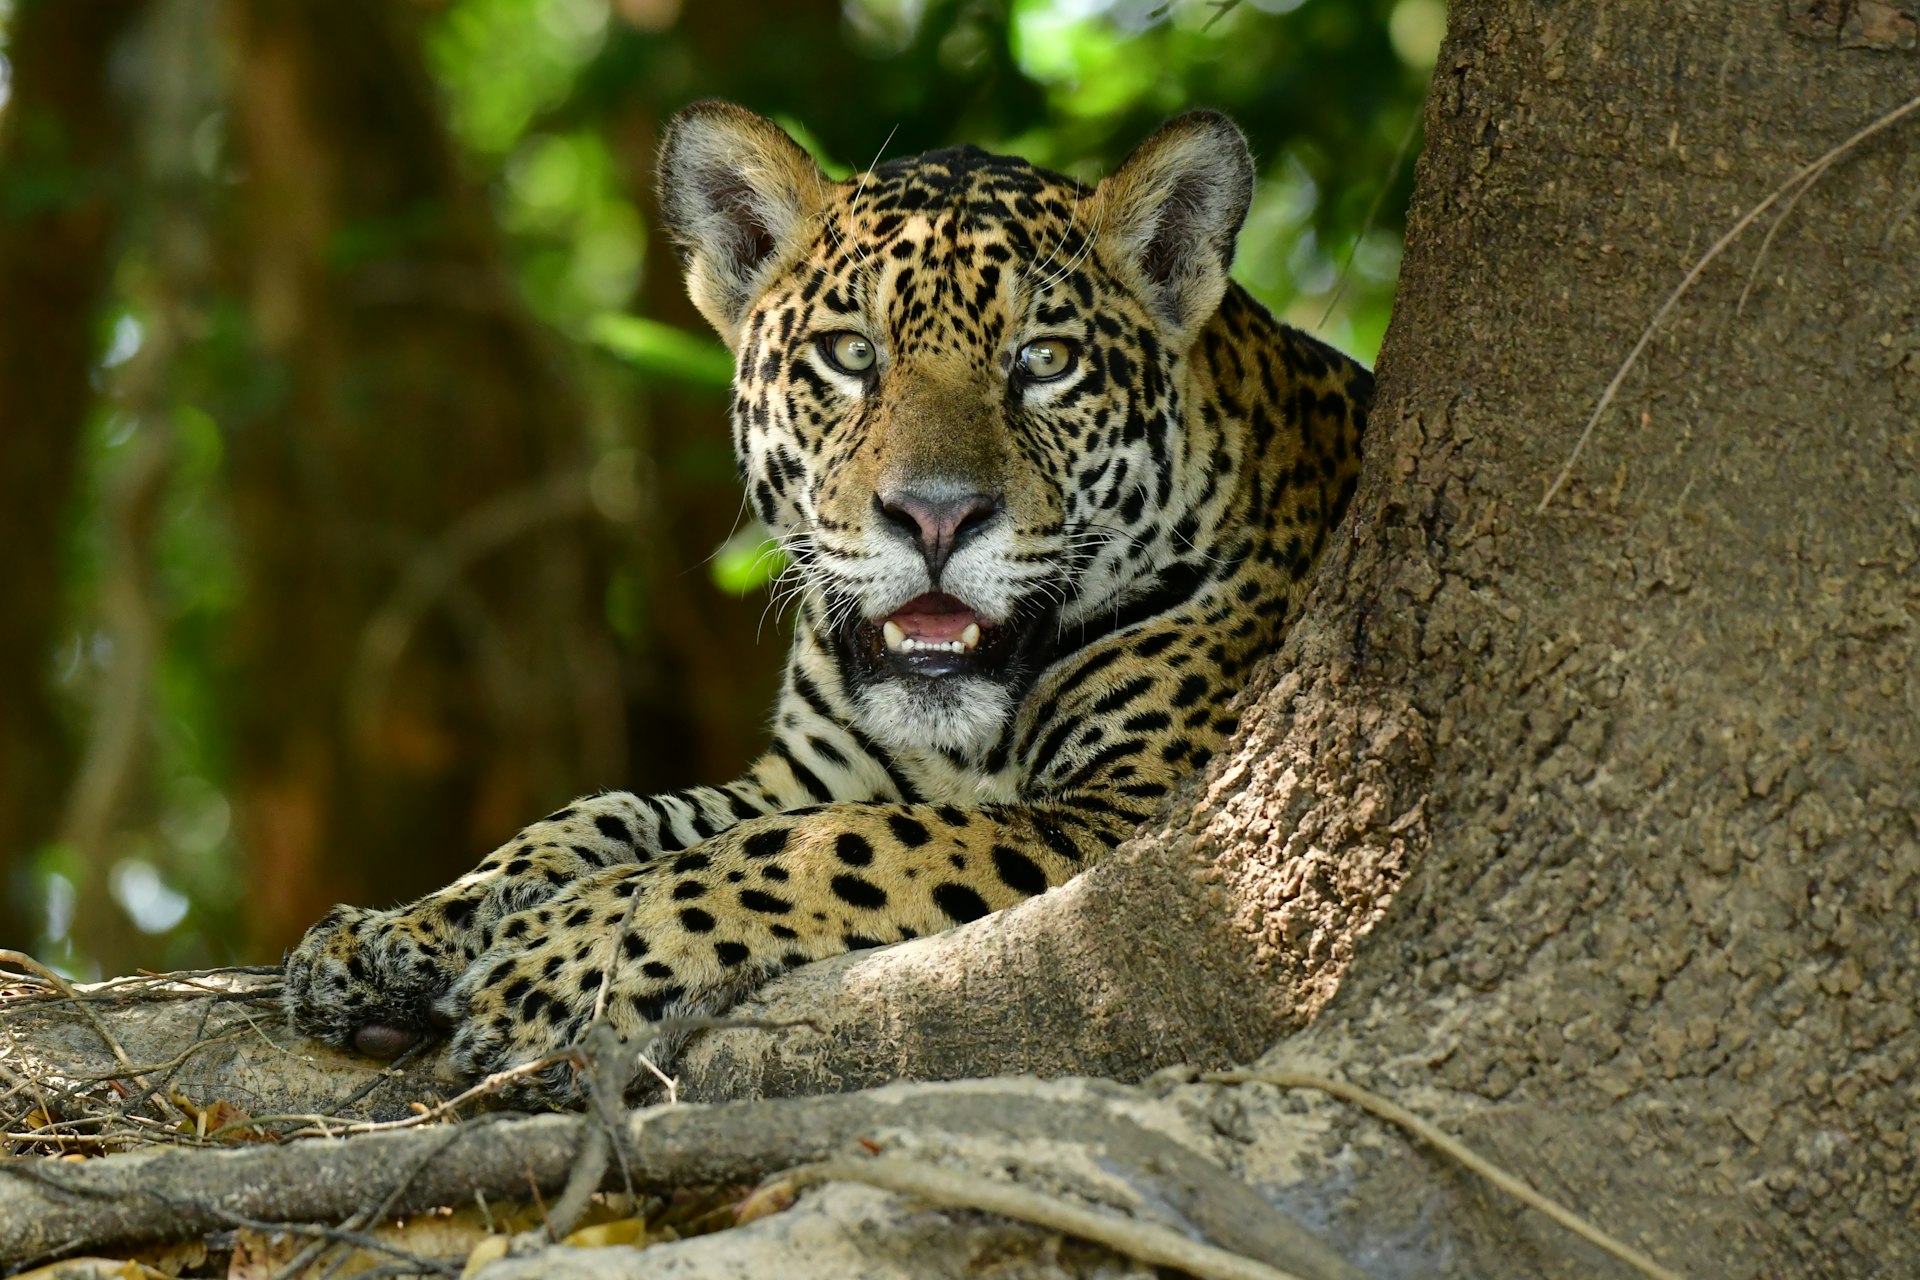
[7,0,1920,1278]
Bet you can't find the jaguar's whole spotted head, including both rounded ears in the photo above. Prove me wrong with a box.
[660,102,1254,750]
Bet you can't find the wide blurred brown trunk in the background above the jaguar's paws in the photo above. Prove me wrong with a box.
[232,0,624,952]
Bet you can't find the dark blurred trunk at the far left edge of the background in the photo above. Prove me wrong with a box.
[0,0,146,951]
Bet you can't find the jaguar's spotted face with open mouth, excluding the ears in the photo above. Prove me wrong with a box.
[737,166,1171,748]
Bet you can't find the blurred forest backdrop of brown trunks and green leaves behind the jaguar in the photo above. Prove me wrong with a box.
[0,0,1446,975]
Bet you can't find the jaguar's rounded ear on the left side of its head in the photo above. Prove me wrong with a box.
[657,100,826,347]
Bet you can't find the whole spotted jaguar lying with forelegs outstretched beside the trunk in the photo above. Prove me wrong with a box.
[284,102,1373,1105]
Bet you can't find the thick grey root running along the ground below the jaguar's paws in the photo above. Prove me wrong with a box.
[0,1080,1354,1280]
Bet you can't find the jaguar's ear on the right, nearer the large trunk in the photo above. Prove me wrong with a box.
[1100,111,1254,344]
